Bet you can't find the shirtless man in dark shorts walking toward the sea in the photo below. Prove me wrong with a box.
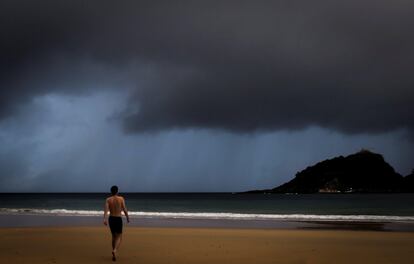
[104,186,129,261]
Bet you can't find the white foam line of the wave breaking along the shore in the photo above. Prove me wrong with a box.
[0,208,414,223]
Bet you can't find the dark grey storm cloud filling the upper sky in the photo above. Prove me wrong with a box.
[0,0,414,133]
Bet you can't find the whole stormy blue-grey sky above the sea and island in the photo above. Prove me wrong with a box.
[0,0,414,192]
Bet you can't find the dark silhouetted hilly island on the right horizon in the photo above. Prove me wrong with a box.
[247,149,414,193]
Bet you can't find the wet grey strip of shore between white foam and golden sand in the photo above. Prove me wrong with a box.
[0,214,414,233]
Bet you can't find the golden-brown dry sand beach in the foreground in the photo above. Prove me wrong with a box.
[0,227,414,264]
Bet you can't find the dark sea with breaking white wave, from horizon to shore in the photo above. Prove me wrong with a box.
[0,193,414,224]
